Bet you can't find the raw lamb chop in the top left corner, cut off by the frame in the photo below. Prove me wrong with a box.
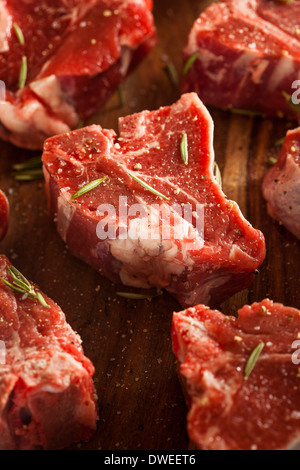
[0,0,156,149]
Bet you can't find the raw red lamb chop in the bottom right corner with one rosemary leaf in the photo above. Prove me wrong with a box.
[172,299,300,450]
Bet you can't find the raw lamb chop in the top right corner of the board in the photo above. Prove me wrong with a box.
[182,0,300,120]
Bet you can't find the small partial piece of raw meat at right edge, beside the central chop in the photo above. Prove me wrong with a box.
[263,127,300,238]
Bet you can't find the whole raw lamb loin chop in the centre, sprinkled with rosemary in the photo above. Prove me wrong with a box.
[43,93,265,306]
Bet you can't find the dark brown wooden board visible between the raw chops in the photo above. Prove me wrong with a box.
[0,0,300,450]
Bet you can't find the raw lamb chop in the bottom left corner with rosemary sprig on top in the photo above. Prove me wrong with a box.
[0,256,97,450]
